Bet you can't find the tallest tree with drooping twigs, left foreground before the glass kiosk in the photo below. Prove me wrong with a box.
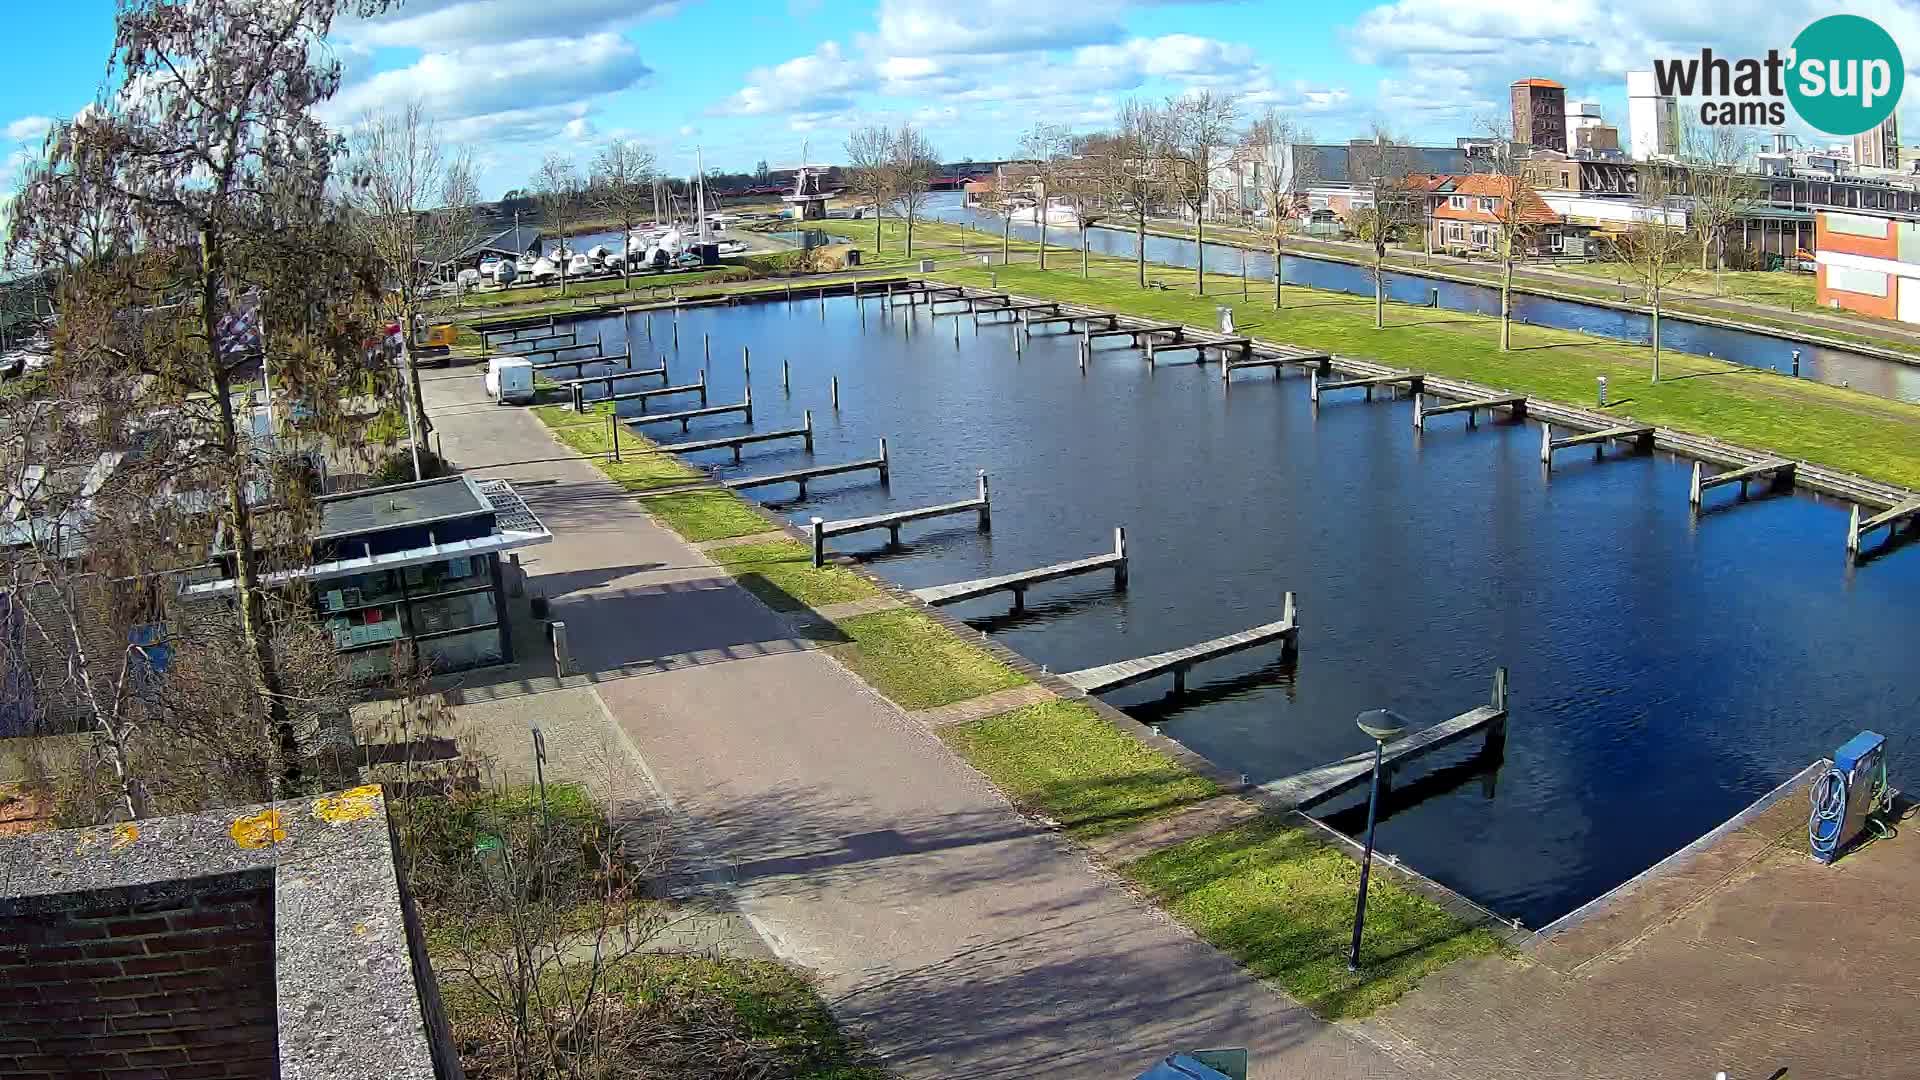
[8,0,388,792]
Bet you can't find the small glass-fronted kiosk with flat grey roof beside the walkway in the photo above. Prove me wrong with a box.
[184,477,553,678]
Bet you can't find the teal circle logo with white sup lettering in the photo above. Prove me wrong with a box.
[1788,15,1907,135]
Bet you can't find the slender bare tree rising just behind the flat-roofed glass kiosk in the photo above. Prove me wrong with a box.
[346,100,441,449]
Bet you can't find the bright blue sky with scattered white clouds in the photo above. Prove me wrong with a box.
[0,0,1920,198]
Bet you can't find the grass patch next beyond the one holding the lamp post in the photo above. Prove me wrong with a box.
[939,701,1219,836]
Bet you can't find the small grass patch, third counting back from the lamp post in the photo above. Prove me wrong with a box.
[831,607,1027,709]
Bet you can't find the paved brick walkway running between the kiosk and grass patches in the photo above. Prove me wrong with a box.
[426,369,1413,1080]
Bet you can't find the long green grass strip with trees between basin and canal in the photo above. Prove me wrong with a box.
[937,259,1920,486]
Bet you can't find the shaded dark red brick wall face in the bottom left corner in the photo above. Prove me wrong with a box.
[0,886,278,1080]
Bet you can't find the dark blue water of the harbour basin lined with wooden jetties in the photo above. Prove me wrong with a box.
[541,300,1920,926]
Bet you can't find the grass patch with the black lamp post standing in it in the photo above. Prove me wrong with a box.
[1121,819,1501,1019]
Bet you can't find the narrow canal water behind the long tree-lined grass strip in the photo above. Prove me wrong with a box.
[913,194,1920,402]
